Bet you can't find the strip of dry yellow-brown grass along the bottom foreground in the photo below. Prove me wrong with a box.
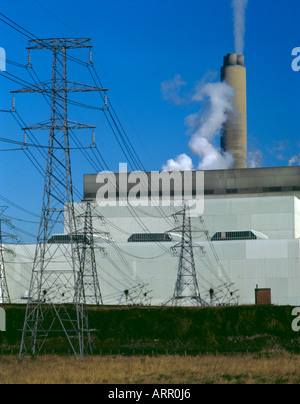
[0,352,300,384]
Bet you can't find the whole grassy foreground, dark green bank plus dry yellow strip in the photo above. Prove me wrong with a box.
[0,305,300,385]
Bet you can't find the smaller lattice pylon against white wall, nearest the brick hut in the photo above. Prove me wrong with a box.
[169,202,208,306]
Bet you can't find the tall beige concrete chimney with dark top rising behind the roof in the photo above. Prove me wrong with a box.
[221,53,247,168]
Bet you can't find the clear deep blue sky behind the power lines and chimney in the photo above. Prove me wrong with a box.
[0,0,300,242]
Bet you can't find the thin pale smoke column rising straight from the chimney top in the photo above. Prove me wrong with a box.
[231,0,248,54]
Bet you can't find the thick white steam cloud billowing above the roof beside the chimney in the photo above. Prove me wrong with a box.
[163,81,235,171]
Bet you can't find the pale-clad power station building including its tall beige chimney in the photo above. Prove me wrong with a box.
[5,54,300,305]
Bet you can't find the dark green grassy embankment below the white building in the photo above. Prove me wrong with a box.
[0,305,300,355]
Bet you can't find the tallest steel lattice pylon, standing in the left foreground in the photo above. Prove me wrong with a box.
[12,38,105,360]
